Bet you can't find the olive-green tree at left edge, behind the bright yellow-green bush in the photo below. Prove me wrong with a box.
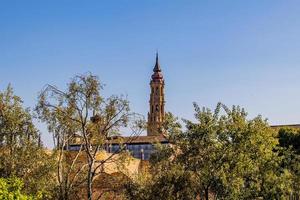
[0,85,54,199]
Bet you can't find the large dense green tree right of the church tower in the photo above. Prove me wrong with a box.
[125,103,293,199]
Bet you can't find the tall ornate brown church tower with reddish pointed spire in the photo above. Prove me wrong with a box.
[147,53,165,136]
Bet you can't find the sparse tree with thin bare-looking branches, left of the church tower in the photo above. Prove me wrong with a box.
[36,74,142,200]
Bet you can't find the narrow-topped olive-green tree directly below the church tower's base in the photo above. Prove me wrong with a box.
[124,112,197,200]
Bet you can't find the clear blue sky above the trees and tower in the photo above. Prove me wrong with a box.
[0,0,300,145]
